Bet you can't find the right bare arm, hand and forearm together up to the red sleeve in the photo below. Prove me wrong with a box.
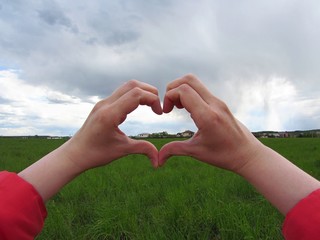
[159,74,320,214]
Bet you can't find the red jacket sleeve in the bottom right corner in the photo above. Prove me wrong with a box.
[282,189,320,240]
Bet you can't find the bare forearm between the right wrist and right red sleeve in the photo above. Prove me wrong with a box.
[238,145,320,215]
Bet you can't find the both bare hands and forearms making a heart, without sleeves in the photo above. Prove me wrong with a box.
[19,74,320,214]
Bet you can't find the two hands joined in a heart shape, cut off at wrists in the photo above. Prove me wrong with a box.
[72,75,257,174]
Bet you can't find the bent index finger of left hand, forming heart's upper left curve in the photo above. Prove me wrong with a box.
[114,88,162,124]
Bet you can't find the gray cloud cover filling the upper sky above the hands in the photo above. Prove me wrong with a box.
[0,0,320,133]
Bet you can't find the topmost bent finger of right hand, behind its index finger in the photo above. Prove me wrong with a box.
[167,74,215,103]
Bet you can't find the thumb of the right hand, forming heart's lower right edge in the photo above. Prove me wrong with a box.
[159,140,191,166]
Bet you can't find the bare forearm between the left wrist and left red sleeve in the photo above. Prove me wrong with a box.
[18,142,82,202]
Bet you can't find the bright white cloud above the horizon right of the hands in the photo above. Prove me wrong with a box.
[233,77,320,131]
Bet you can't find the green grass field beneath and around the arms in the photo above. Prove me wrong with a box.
[0,138,320,240]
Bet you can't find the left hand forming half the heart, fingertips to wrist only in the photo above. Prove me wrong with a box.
[65,80,162,171]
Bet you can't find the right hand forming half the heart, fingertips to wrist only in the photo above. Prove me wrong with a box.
[159,75,261,172]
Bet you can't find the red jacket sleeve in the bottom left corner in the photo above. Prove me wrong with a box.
[0,171,47,240]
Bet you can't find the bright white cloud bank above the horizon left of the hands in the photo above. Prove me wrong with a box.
[0,70,93,135]
